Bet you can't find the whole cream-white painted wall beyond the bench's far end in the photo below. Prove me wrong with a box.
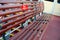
[44,1,60,16]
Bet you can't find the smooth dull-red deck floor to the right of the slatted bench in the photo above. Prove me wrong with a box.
[42,16,60,40]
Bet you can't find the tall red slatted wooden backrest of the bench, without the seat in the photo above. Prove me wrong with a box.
[0,2,44,40]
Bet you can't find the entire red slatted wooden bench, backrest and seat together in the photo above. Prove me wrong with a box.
[0,2,44,40]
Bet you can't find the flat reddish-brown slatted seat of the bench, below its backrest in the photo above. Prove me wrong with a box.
[10,15,50,40]
